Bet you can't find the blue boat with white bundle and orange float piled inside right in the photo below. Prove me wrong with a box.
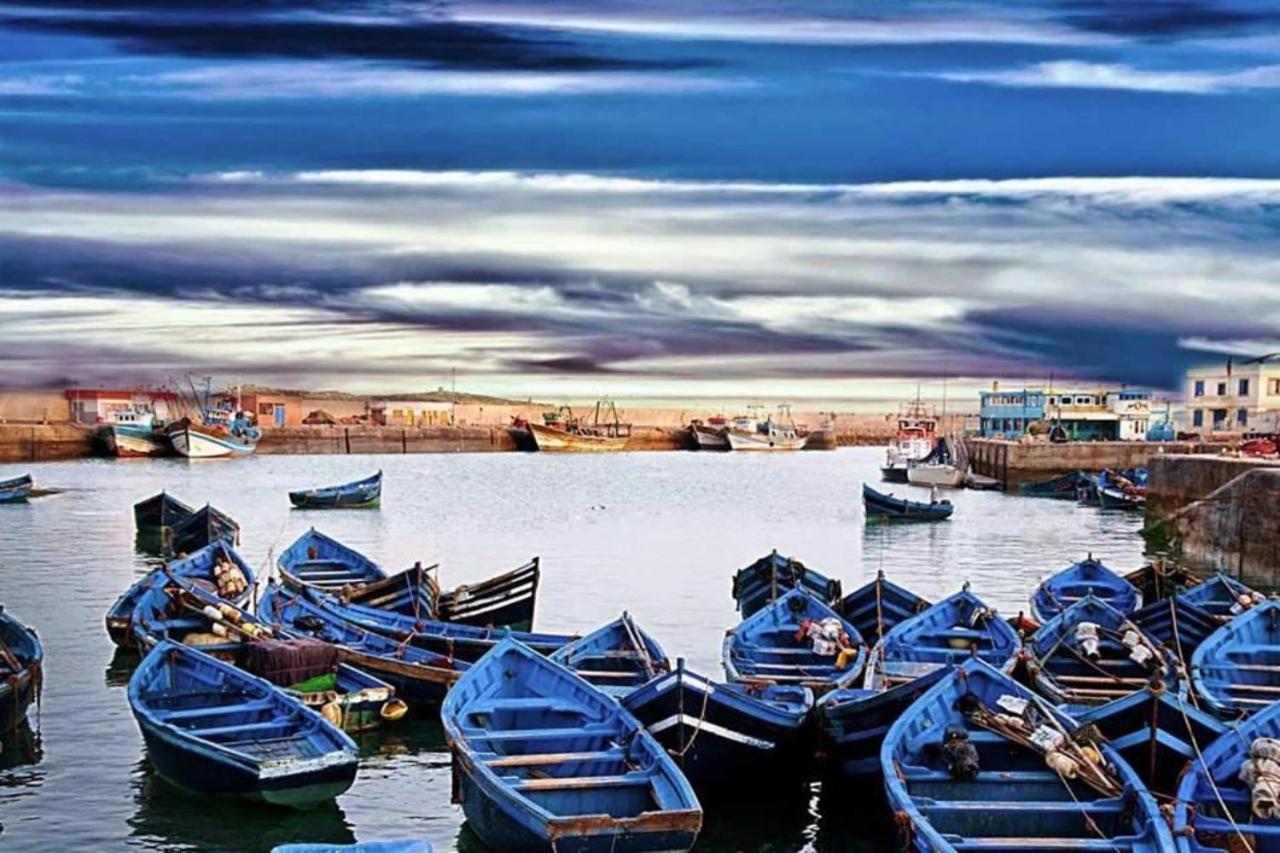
[721,589,867,694]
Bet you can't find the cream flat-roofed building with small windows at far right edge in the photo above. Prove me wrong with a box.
[1185,352,1280,433]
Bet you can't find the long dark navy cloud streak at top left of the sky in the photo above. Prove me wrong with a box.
[0,1,700,72]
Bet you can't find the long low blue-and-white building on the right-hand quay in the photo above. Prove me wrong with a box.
[978,383,1153,442]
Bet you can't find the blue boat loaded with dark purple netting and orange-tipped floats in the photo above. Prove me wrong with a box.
[132,570,408,731]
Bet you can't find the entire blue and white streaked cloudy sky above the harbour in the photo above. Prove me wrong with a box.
[0,0,1280,402]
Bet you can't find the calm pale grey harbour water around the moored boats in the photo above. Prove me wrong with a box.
[0,448,1142,852]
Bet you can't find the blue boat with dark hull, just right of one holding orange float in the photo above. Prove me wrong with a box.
[818,589,1018,780]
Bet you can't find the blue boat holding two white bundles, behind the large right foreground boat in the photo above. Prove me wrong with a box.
[1021,596,1185,716]
